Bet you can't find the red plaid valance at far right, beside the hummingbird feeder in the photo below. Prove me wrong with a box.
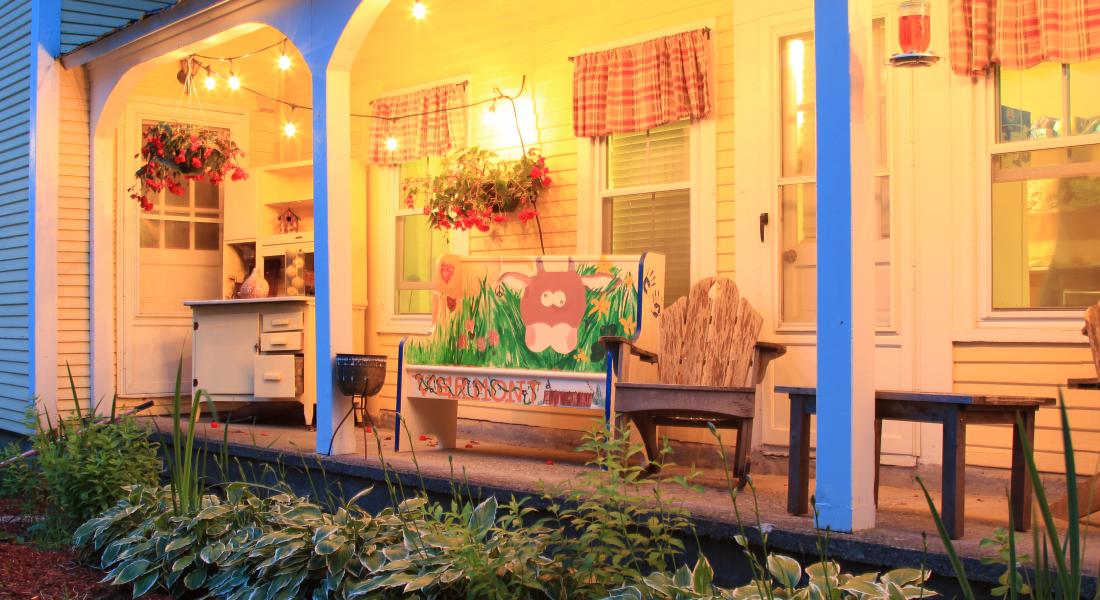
[950,0,1100,75]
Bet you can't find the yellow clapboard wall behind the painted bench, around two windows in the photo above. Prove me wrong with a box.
[351,0,734,429]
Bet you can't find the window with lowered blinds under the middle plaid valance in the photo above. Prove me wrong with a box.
[601,120,693,304]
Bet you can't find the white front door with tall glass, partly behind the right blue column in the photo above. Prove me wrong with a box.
[734,0,920,465]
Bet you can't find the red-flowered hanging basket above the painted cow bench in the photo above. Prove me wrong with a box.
[402,146,551,232]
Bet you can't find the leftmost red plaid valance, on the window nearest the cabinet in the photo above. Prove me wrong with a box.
[367,84,465,165]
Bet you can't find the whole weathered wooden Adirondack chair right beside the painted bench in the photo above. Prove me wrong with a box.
[602,277,787,484]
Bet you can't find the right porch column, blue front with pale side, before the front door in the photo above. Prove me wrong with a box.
[814,0,875,532]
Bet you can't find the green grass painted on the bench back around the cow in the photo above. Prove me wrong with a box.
[405,264,638,373]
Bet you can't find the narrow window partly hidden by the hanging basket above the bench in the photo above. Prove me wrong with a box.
[391,157,451,316]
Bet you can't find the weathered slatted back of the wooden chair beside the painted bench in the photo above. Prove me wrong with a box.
[658,277,763,388]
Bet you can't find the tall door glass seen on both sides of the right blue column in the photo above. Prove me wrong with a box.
[777,19,893,327]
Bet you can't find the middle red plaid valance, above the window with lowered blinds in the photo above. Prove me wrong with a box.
[573,30,711,138]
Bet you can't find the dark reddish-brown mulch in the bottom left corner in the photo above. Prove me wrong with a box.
[0,500,171,600]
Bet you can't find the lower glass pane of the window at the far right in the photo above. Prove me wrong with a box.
[991,144,1100,309]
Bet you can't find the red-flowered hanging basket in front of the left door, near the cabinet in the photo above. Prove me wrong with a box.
[130,122,249,210]
